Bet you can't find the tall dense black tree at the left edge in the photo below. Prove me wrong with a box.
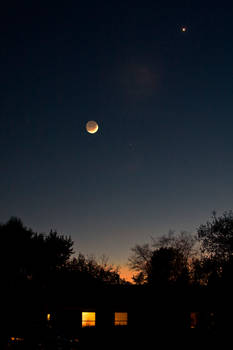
[0,217,73,286]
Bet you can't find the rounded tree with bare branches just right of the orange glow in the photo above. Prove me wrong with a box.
[129,231,196,285]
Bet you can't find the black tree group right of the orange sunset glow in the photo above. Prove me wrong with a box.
[129,211,233,289]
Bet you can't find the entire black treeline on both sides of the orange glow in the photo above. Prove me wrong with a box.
[0,211,233,294]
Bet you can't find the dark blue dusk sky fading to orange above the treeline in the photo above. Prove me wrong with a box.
[0,0,233,278]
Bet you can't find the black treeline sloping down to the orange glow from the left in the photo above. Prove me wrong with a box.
[0,217,126,288]
